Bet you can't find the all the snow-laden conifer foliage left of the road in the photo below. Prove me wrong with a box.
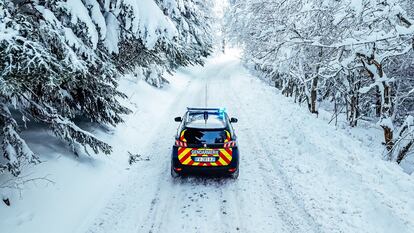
[0,0,212,176]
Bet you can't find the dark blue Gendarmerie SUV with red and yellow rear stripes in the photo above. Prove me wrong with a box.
[171,108,239,178]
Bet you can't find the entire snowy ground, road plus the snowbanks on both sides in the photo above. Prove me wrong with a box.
[4,51,414,233]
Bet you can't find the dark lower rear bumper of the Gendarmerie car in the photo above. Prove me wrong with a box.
[171,146,239,175]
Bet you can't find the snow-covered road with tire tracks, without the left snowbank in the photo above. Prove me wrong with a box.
[80,51,414,233]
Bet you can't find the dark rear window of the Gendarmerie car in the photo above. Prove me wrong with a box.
[184,129,227,144]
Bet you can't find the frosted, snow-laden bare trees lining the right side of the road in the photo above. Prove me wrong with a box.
[226,0,414,167]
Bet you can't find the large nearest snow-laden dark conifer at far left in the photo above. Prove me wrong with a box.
[0,1,129,175]
